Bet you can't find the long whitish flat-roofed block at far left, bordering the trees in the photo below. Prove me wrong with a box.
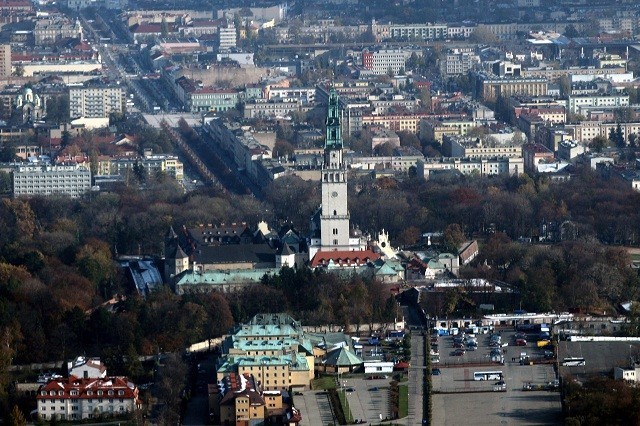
[12,165,91,197]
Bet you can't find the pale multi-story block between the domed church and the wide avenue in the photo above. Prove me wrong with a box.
[69,84,126,118]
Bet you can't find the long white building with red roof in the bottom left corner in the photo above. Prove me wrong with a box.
[36,376,141,420]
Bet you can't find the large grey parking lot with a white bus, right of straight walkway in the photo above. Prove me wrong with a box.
[432,330,561,425]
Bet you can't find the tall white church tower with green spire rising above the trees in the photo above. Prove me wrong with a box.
[320,89,350,251]
